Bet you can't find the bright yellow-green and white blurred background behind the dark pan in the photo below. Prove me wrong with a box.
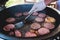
[5,0,56,8]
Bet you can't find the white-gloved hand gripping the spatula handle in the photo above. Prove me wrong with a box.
[29,0,46,13]
